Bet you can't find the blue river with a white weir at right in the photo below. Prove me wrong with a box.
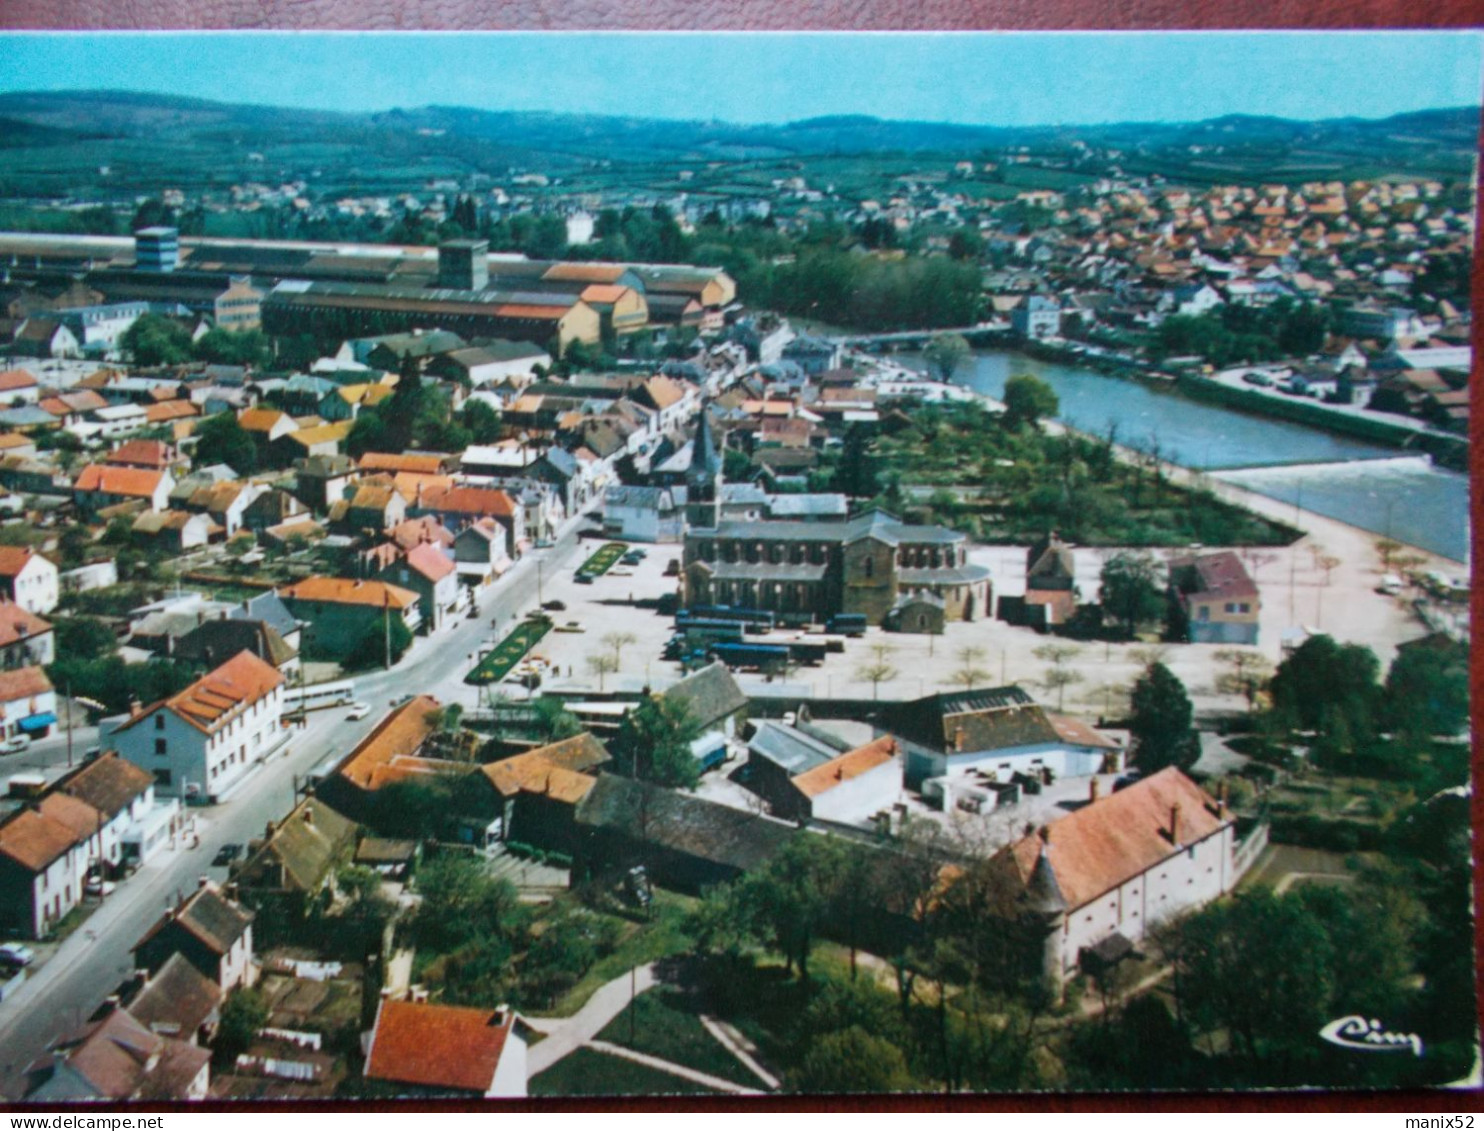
[895,350,1469,561]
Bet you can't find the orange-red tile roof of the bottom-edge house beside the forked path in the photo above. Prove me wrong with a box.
[365,1000,515,1095]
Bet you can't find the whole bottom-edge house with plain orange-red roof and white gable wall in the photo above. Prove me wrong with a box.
[365,997,525,1098]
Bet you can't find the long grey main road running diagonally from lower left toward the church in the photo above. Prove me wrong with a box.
[0,515,586,1098]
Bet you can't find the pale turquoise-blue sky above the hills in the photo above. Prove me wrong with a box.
[0,31,1484,126]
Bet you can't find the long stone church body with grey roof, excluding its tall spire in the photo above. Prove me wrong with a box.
[683,507,991,625]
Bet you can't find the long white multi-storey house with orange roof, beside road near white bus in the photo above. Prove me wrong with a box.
[102,652,288,799]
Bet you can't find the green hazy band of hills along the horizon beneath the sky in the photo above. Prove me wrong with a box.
[0,91,1480,196]
